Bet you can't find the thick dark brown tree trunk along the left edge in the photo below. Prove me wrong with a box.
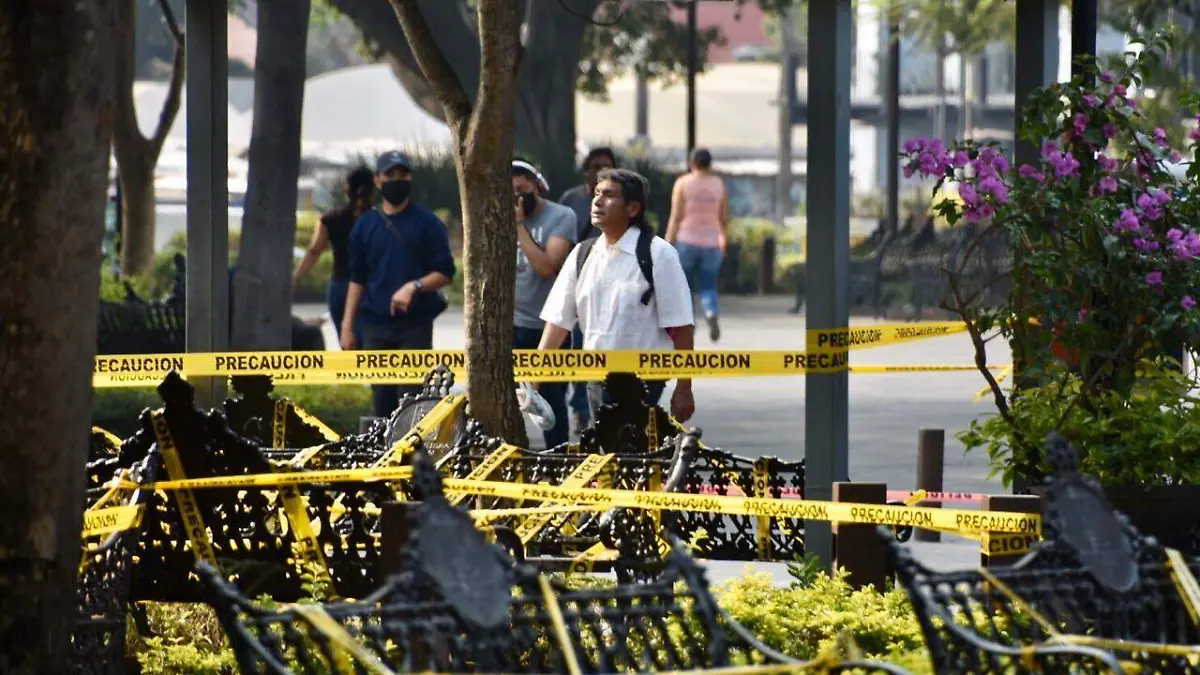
[0,0,116,675]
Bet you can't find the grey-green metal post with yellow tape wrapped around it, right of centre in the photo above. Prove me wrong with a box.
[804,0,853,567]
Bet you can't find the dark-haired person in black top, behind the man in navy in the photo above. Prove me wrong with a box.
[292,167,374,344]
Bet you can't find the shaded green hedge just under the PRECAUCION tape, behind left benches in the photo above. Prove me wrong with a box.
[91,384,371,438]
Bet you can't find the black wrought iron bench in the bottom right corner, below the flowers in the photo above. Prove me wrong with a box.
[881,435,1200,675]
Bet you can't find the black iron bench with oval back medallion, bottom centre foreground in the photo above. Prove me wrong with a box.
[200,453,900,675]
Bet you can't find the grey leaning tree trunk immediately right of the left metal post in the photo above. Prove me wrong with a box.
[229,0,311,350]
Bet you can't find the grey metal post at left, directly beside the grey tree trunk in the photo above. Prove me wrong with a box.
[186,2,229,407]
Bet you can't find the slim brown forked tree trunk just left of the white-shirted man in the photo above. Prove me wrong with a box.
[391,0,527,446]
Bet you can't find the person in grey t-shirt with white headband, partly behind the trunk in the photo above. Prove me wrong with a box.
[512,159,576,448]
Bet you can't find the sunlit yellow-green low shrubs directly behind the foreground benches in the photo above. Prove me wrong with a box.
[128,564,932,675]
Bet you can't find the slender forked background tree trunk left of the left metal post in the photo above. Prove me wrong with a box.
[113,0,184,275]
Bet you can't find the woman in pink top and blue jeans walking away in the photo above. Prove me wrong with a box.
[667,148,730,342]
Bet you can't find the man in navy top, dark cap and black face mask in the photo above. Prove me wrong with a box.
[341,151,455,417]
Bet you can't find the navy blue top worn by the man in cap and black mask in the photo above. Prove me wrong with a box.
[349,203,455,324]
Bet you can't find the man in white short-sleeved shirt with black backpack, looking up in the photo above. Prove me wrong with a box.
[538,169,696,422]
